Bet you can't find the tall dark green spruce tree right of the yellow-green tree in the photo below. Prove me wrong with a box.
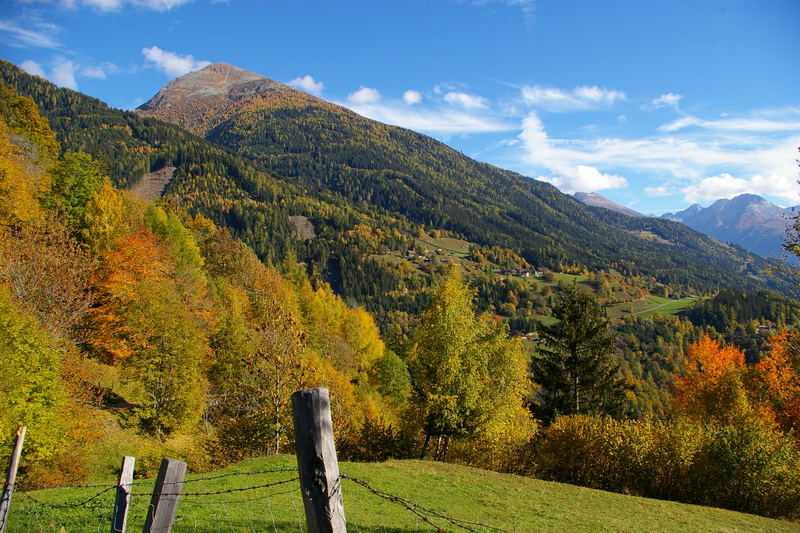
[531,285,625,423]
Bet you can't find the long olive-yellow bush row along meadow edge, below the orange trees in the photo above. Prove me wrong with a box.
[535,415,800,518]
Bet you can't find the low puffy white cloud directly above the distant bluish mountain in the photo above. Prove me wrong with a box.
[681,173,800,204]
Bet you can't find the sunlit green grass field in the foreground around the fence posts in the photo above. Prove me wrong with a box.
[7,456,800,533]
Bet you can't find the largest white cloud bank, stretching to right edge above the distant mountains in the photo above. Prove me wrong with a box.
[519,113,800,201]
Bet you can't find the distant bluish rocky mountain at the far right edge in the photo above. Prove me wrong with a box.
[662,194,800,257]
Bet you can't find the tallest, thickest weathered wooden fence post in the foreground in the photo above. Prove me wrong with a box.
[292,387,347,533]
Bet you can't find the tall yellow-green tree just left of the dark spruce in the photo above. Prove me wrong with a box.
[408,267,536,460]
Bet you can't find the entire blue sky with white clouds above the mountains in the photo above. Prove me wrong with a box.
[0,0,800,213]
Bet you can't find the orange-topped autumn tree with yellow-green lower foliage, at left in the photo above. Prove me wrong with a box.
[87,229,208,436]
